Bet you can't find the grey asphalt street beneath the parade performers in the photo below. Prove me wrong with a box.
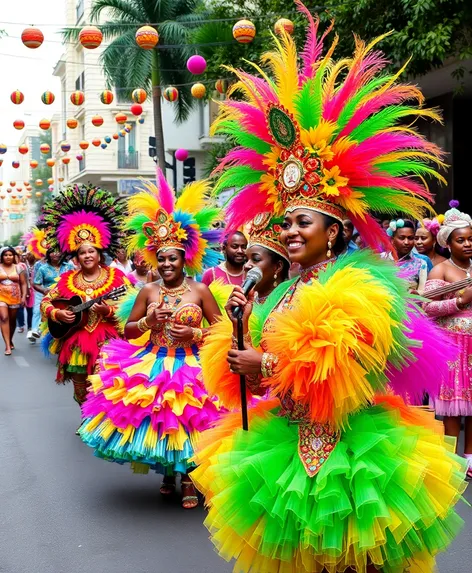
[0,335,472,573]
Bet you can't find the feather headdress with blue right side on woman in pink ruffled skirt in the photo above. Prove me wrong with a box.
[124,169,222,275]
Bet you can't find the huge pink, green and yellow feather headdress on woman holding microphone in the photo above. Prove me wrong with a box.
[212,0,444,249]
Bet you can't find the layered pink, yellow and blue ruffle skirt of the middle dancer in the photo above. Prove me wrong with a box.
[79,340,219,474]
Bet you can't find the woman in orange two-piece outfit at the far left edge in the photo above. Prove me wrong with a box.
[0,247,28,356]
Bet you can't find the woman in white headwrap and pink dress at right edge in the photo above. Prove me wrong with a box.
[424,203,472,477]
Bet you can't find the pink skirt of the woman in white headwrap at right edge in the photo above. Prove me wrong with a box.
[430,332,472,416]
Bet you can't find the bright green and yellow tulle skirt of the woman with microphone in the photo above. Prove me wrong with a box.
[192,398,466,573]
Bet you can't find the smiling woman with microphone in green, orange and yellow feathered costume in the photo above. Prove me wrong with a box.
[192,3,465,573]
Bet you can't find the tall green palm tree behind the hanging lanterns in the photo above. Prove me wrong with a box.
[62,0,203,169]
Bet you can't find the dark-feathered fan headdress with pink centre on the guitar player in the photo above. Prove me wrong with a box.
[43,185,125,256]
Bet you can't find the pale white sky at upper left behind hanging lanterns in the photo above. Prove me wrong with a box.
[0,0,66,181]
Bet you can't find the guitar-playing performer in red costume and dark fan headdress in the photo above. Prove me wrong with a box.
[41,186,130,405]
